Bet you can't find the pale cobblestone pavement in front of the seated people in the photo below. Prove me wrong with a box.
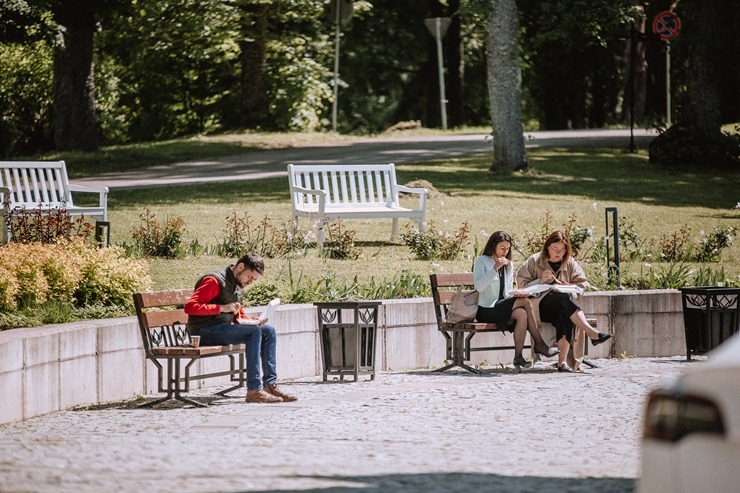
[0,356,701,493]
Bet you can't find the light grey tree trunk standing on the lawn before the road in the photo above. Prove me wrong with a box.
[487,0,529,171]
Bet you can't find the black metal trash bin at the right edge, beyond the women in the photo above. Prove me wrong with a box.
[679,286,740,360]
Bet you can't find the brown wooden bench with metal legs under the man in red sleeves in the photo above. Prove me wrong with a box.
[134,289,246,407]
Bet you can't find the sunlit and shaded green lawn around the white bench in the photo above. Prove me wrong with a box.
[92,139,740,289]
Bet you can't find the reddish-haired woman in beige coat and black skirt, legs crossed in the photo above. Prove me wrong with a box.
[517,231,611,372]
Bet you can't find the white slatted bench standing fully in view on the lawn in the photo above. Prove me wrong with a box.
[288,163,427,247]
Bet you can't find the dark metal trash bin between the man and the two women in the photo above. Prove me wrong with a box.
[314,301,382,382]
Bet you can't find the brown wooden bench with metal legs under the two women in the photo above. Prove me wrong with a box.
[429,272,596,373]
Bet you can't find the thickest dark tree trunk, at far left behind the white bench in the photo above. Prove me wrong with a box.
[53,1,98,151]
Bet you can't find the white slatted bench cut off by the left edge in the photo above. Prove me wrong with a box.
[0,161,110,243]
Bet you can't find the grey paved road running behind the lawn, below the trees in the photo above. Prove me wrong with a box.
[73,129,656,190]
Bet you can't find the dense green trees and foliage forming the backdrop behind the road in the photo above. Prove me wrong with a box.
[0,0,740,170]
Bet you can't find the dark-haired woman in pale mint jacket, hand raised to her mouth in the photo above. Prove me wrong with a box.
[473,231,557,370]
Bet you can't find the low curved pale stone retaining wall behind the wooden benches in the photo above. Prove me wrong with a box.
[0,290,686,424]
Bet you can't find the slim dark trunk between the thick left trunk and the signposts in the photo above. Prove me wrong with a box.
[239,1,269,129]
